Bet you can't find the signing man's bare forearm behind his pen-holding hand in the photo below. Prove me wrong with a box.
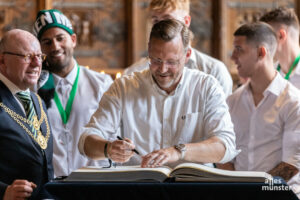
[84,135,108,160]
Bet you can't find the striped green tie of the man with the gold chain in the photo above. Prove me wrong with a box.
[17,91,36,137]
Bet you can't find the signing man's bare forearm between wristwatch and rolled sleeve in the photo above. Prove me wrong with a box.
[185,136,226,163]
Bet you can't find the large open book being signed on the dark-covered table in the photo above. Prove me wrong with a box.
[64,163,272,183]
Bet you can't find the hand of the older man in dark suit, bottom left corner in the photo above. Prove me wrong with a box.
[3,180,36,200]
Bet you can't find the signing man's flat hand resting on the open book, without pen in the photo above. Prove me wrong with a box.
[141,147,180,167]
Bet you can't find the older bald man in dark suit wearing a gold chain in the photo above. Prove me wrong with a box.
[0,29,53,200]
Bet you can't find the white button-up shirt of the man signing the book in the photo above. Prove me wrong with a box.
[79,68,238,165]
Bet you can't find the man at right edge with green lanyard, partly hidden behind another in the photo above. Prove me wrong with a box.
[260,7,300,89]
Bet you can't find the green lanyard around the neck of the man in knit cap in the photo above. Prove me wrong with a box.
[42,64,80,124]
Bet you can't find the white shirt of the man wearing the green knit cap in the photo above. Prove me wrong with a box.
[48,64,112,176]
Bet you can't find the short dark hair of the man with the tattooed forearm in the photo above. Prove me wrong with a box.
[233,22,277,56]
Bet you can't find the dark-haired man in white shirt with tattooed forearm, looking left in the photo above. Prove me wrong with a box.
[220,22,300,195]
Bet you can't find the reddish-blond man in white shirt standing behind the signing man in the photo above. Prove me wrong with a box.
[124,0,232,96]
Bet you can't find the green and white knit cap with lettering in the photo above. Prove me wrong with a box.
[33,9,74,39]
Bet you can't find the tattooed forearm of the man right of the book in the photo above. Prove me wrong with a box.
[268,162,299,182]
